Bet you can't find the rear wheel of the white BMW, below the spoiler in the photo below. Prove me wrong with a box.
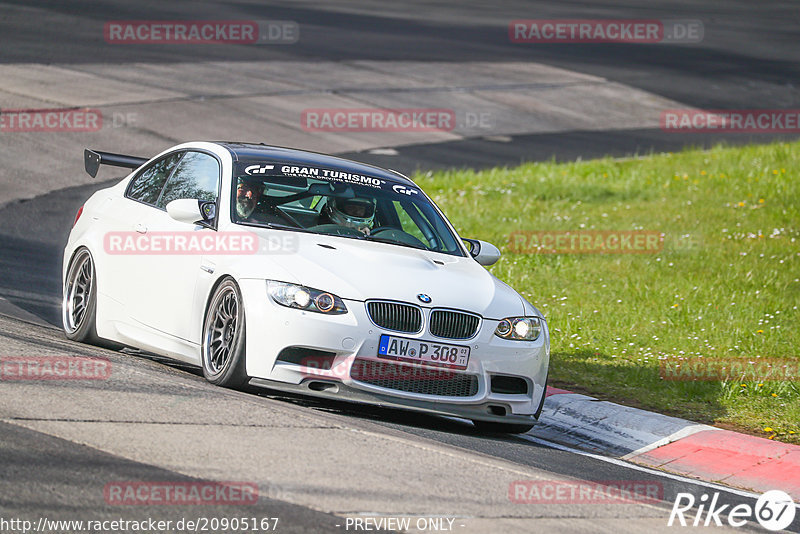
[61,248,123,350]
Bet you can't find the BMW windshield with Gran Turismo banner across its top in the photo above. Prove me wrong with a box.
[231,162,463,256]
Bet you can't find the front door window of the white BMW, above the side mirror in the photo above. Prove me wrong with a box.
[156,152,220,208]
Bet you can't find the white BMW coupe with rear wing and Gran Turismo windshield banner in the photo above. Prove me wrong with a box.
[63,142,550,433]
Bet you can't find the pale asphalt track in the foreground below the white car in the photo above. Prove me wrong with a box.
[0,317,780,532]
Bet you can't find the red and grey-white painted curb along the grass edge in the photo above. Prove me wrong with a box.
[531,388,800,502]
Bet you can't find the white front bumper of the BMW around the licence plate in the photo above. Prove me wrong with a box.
[240,279,550,423]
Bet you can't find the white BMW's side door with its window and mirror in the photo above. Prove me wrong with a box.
[130,150,221,343]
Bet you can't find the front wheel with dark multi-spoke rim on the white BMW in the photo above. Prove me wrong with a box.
[201,278,250,389]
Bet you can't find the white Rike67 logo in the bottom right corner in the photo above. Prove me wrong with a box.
[667,490,797,532]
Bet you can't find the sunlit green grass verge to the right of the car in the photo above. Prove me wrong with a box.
[415,143,800,443]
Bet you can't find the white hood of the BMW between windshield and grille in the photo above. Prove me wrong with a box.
[237,229,525,319]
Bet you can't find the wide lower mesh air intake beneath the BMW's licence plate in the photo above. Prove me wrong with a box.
[350,358,478,397]
